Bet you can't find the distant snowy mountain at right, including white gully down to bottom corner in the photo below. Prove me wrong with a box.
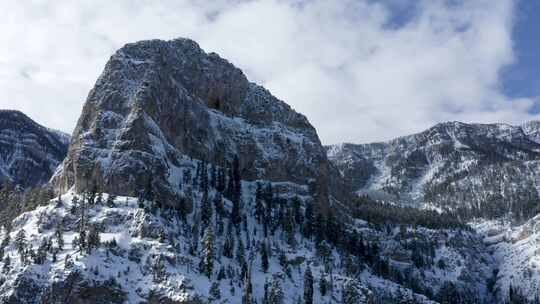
[326,121,540,303]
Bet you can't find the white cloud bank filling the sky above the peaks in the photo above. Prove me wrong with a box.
[0,0,535,143]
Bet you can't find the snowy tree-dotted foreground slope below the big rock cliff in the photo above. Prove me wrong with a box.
[0,182,492,304]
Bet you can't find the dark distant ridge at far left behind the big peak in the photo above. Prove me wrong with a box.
[0,110,69,188]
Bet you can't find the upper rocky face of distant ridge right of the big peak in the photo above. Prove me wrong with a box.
[327,122,540,217]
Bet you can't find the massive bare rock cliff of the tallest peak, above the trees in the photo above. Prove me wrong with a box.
[54,39,329,209]
